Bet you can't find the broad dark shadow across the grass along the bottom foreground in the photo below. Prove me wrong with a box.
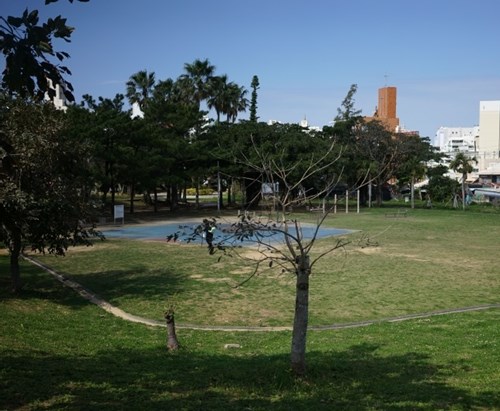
[0,344,500,410]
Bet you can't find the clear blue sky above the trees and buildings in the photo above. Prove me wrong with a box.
[0,0,500,138]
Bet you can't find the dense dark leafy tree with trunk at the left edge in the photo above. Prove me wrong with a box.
[0,97,97,292]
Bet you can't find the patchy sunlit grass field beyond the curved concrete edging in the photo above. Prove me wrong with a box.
[20,210,500,326]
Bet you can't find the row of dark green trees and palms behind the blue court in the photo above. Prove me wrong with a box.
[61,80,442,213]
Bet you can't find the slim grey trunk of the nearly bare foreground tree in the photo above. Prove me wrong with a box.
[291,256,311,376]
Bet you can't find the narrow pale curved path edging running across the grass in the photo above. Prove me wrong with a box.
[23,256,500,332]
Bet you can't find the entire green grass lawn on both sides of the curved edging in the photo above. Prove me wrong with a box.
[0,209,500,410]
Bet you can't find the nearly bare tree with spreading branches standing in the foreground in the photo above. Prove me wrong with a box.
[188,138,368,376]
